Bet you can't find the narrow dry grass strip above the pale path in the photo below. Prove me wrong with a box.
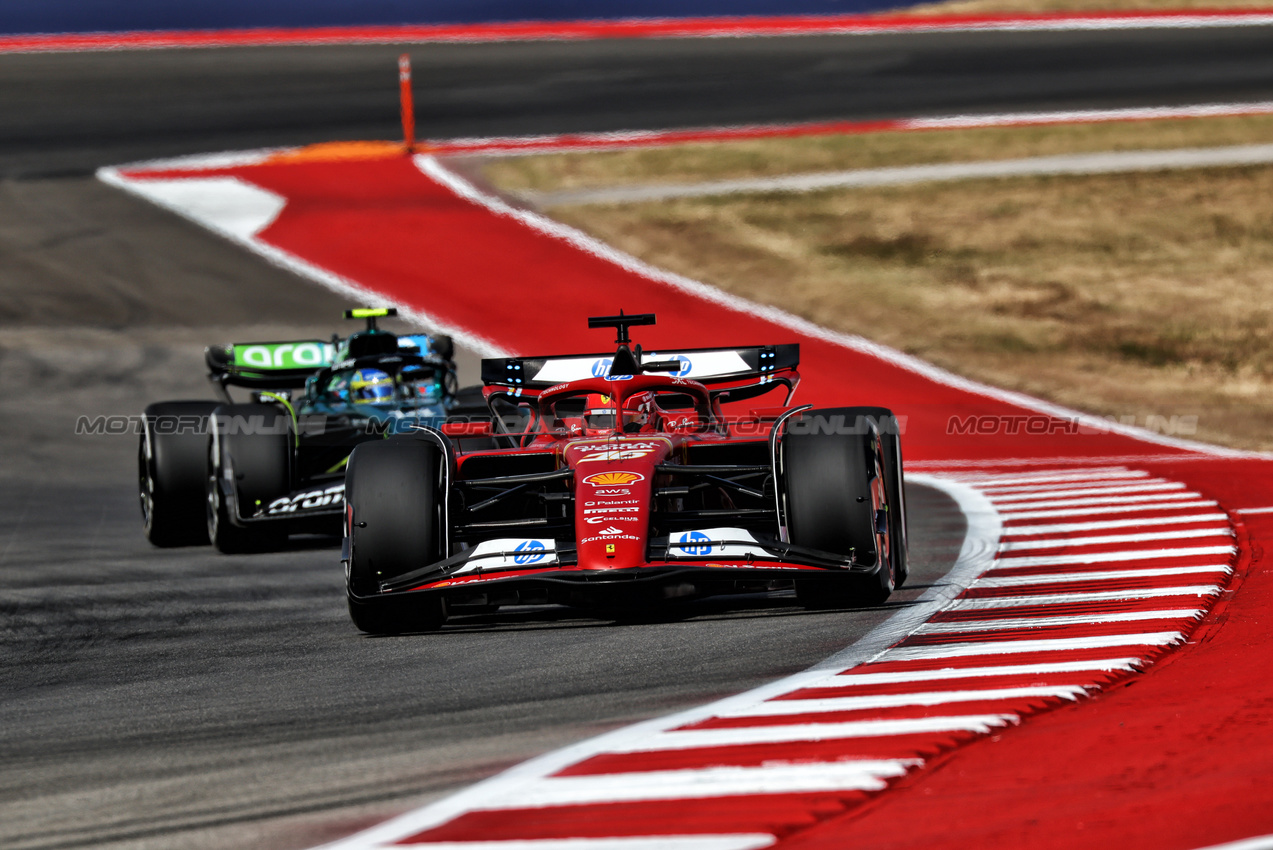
[484,116,1273,192]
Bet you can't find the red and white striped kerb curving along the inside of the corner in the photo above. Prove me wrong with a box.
[315,467,1237,850]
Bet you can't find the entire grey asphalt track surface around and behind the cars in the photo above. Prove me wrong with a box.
[0,28,1273,847]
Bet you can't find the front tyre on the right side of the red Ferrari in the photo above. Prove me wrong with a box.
[782,408,894,610]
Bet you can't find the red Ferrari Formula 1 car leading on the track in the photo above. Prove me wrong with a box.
[342,313,906,634]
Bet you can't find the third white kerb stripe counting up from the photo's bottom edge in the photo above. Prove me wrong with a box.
[607,714,1017,753]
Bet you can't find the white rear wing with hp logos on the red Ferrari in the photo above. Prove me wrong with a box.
[481,342,799,392]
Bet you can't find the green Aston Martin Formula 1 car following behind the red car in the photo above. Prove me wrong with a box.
[137,308,485,552]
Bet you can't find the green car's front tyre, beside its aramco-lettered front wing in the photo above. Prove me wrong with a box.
[206,405,295,555]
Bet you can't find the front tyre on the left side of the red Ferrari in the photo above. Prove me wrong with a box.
[345,436,446,635]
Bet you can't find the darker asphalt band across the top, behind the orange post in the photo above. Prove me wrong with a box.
[0,27,1273,176]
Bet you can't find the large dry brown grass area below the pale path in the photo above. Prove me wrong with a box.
[529,168,1273,449]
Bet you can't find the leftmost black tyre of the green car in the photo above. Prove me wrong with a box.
[137,401,216,547]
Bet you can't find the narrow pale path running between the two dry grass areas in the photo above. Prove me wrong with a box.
[521,145,1273,206]
